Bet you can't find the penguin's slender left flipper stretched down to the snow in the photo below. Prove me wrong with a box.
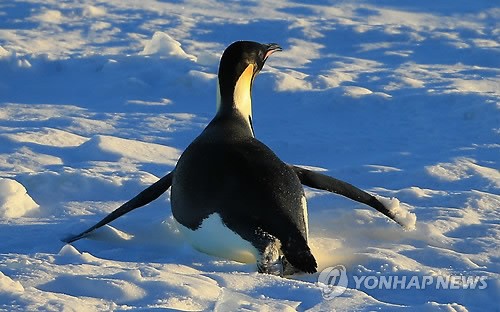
[62,171,174,244]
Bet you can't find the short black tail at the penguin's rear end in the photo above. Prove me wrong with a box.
[281,235,318,273]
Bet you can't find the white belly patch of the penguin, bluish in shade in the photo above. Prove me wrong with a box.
[176,213,259,263]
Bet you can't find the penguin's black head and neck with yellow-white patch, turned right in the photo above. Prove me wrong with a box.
[217,41,281,134]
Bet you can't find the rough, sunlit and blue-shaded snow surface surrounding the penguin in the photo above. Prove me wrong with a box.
[0,0,500,311]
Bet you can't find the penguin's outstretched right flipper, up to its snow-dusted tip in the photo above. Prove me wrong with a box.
[292,166,405,227]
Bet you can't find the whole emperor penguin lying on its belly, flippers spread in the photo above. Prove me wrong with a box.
[63,41,403,276]
